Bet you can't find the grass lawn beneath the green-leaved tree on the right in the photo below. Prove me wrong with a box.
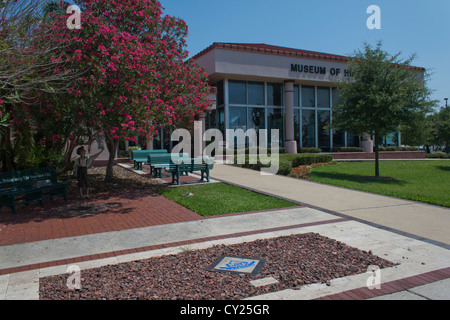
[311,160,450,207]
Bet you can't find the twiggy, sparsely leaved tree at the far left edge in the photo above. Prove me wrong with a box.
[0,0,82,171]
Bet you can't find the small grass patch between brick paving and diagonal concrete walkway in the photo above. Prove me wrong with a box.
[159,183,298,217]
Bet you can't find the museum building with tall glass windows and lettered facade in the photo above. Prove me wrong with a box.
[192,43,425,153]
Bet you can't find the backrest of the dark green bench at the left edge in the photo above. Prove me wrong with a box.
[0,167,56,190]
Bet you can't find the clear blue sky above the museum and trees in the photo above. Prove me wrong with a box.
[160,0,450,106]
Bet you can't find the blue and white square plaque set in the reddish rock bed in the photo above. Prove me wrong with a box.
[207,255,266,276]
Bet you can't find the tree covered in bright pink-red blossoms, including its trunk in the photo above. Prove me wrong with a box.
[45,0,210,181]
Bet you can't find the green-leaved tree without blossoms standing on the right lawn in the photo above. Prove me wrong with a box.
[332,42,435,177]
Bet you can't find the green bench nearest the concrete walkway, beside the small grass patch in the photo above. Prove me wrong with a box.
[166,158,214,185]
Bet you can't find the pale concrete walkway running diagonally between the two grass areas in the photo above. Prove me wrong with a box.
[211,164,450,248]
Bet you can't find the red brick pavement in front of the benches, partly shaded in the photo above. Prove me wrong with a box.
[0,190,202,245]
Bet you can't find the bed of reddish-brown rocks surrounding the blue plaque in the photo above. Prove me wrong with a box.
[40,233,396,300]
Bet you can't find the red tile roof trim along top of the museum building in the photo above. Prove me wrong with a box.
[191,42,425,72]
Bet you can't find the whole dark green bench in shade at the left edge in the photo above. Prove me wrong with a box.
[0,167,69,213]
